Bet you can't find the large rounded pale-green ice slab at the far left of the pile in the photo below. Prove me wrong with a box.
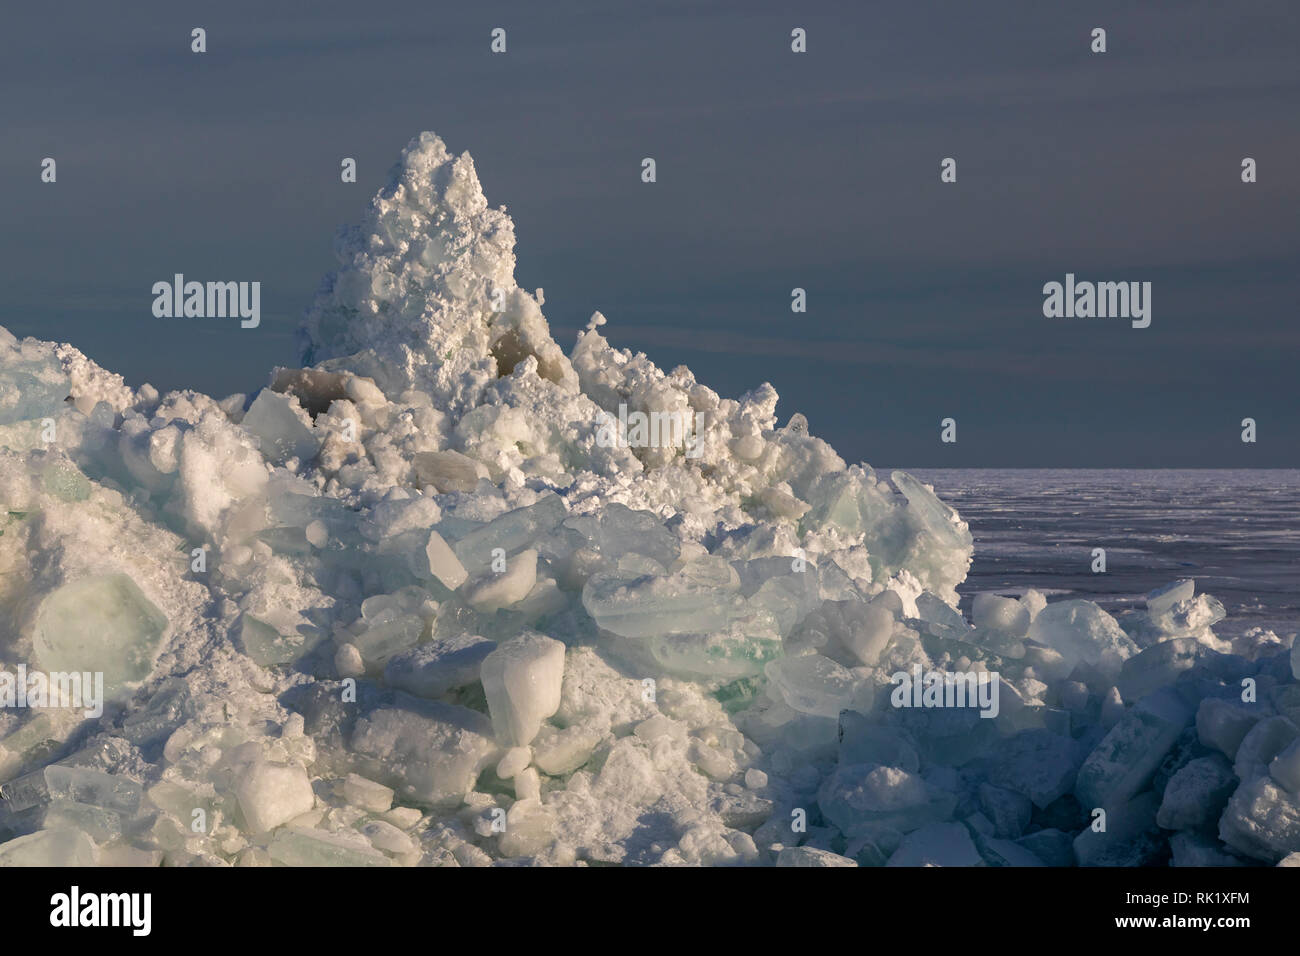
[33,574,168,697]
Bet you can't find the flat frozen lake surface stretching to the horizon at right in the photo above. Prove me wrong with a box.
[911,468,1300,637]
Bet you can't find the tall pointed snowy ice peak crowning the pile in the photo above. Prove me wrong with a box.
[298,133,573,401]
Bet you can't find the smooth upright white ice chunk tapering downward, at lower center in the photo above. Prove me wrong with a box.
[481,633,564,747]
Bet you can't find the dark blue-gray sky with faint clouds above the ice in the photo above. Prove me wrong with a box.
[0,0,1300,467]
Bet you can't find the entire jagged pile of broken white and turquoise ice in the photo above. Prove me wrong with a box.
[0,134,1300,866]
